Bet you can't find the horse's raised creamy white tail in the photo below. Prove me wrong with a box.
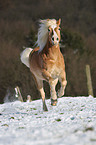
[20,48,33,67]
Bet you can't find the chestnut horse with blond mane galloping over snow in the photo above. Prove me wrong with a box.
[21,19,67,111]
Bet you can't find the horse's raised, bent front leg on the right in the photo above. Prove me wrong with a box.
[58,71,67,97]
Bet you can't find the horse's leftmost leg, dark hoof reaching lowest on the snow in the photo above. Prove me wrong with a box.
[33,75,48,111]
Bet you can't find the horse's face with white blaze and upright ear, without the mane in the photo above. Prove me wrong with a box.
[48,19,61,45]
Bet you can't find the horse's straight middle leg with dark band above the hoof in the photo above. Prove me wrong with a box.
[49,78,58,106]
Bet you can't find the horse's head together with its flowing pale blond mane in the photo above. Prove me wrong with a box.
[36,19,61,52]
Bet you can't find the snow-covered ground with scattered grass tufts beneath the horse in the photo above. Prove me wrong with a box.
[0,96,96,145]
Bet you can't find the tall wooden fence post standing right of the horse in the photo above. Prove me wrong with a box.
[86,65,93,96]
